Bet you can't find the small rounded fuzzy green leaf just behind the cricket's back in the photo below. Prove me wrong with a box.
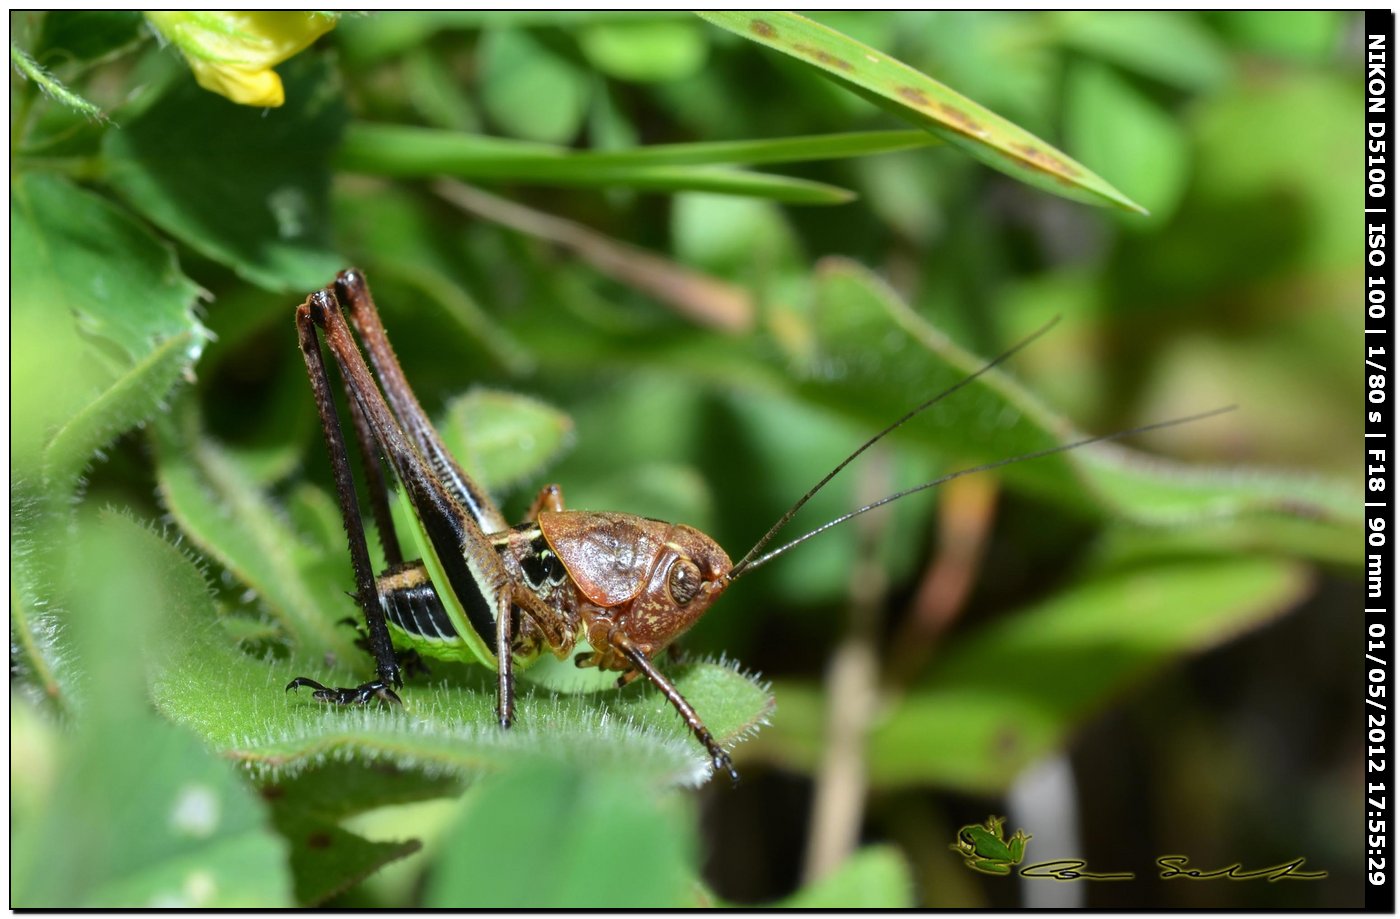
[440,389,574,493]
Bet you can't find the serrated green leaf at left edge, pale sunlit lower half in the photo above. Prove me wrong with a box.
[10,174,204,487]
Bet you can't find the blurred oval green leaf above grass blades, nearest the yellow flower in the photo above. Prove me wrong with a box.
[477,28,588,143]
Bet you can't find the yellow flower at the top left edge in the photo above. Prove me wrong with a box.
[146,11,336,108]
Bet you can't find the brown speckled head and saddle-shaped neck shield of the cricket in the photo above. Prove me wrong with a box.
[539,511,732,654]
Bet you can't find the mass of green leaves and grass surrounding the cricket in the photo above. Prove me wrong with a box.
[10,11,1361,908]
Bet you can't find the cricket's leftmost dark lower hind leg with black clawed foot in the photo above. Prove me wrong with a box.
[287,304,403,705]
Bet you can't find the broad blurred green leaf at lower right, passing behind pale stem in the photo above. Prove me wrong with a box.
[756,555,1308,794]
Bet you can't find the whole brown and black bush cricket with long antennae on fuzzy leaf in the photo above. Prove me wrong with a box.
[287,269,1228,780]
